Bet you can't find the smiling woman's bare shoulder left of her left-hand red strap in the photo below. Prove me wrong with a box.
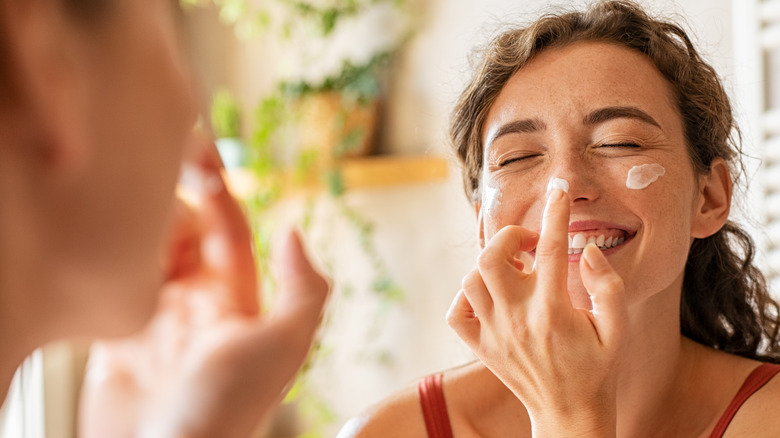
[337,378,427,438]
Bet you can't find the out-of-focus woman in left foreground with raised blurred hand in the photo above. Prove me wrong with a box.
[0,0,328,437]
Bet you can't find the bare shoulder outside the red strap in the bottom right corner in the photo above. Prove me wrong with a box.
[724,362,780,437]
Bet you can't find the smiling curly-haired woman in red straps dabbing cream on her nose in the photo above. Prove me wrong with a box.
[342,1,780,437]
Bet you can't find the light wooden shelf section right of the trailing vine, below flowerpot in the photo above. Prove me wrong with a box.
[340,155,449,190]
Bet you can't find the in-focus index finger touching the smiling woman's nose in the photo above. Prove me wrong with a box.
[534,183,570,301]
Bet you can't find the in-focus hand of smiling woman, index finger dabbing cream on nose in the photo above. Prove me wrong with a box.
[447,189,628,437]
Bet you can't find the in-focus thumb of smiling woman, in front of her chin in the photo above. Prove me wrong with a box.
[580,244,628,345]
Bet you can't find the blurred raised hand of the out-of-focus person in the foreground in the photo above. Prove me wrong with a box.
[79,140,329,438]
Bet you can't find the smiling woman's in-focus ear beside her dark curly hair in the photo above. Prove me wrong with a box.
[691,157,732,239]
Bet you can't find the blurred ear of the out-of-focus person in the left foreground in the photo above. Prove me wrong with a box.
[0,0,87,173]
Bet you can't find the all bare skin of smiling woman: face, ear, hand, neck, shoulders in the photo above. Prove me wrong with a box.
[343,41,780,437]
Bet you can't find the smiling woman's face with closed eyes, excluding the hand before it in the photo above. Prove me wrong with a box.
[478,42,698,308]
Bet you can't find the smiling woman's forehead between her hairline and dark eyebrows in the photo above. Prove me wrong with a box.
[481,41,682,141]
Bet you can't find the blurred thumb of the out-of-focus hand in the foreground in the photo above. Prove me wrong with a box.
[272,231,330,335]
